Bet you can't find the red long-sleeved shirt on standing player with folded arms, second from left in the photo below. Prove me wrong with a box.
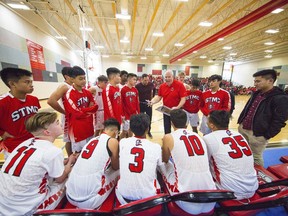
[64,86,98,142]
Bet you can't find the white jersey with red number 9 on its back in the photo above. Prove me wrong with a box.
[66,133,116,202]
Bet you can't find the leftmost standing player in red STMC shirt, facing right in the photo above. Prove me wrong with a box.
[0,68,41,158]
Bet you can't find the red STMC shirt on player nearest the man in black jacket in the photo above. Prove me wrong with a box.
[200,88,231,116]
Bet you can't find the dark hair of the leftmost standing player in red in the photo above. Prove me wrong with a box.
[0,67,32,88]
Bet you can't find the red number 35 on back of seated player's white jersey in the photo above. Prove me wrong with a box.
[222,135,252,159]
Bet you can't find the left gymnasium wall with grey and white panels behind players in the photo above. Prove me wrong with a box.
[0,5,81,99]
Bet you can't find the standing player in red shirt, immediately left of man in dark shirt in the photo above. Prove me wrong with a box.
[120,73,140,139]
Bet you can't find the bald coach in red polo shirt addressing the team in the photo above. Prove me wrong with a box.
[149,71,186,134]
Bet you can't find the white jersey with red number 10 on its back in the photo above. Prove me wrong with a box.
[171,129,216,192]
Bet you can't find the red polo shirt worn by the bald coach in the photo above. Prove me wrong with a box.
[158,80,186,108]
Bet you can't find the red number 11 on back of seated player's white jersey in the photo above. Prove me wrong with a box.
[4,146,36,176]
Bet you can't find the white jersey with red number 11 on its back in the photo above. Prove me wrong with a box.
[0,138,64,215]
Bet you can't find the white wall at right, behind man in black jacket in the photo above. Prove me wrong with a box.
[232,56,288,87]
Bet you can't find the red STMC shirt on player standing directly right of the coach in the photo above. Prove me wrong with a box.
[183,90,202,113]
